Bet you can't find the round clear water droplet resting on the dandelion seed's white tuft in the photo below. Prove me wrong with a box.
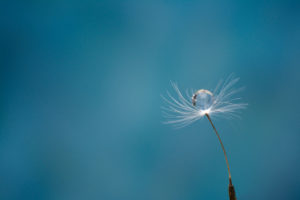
[193,89,214,110]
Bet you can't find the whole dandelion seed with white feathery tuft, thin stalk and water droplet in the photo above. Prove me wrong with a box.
[162,75,247,200]
